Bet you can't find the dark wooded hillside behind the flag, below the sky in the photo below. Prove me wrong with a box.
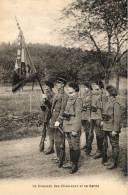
[0,43,127,83]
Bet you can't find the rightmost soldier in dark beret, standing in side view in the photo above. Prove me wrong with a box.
[102,85,120,169]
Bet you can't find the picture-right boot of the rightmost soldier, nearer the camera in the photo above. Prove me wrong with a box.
[107,149,119,169]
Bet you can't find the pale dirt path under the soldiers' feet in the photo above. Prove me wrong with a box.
[0,131,124,180]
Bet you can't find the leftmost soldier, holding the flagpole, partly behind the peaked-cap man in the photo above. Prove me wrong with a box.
[39,80,54,152]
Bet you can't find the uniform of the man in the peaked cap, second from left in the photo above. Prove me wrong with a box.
[46,89,67,159]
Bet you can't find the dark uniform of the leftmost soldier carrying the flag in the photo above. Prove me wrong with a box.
[39,89,53,151]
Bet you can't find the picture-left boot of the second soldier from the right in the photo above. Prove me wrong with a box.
[93,136,103,159]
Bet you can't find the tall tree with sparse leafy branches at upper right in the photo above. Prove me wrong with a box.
[62,0,127,87]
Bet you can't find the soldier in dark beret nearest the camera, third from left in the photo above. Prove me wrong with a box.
[63,82,82,174]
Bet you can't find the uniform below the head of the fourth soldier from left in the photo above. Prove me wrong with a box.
[81,91,91,149]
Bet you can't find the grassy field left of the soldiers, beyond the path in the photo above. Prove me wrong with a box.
[0,86,41,141]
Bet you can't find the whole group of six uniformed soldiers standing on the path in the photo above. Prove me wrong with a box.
[39,77,120,174]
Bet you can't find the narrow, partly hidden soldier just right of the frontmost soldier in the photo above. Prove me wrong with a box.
[81,82,92,152]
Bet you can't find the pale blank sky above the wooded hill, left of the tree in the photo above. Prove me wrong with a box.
[0,0,72,45]
